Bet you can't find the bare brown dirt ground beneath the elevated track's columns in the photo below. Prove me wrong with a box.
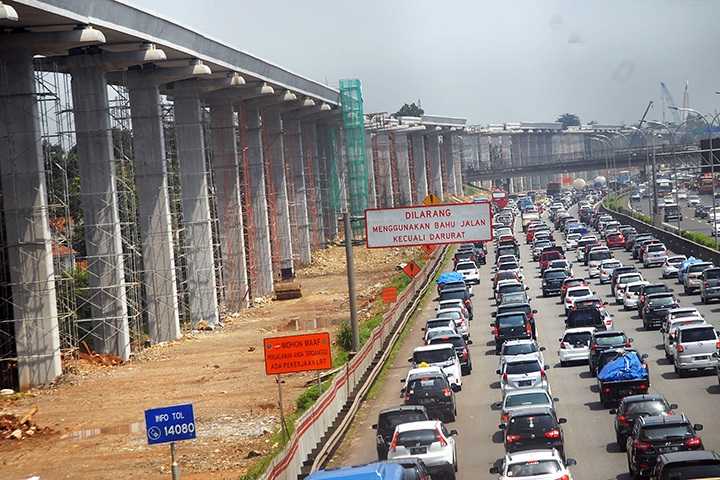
[0,246,417,480]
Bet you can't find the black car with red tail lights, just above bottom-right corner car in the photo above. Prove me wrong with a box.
[625,414,703,478]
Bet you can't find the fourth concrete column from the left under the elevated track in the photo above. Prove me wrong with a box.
[175,93,220,326]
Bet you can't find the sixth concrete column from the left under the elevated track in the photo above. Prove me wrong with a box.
[241,104,273,298]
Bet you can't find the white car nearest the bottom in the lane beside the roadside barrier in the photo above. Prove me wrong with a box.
[388,420,458,478]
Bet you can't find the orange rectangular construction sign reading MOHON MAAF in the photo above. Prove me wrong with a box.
[263,332,332,375]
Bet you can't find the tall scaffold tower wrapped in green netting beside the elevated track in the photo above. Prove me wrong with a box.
[340,79,368,238]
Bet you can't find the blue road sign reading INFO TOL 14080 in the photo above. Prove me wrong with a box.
[145,403,195,445]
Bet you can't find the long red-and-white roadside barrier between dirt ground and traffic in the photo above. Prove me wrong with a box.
[261,247,447,480]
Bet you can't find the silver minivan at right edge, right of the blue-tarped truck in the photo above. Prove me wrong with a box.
[673,325,718,376]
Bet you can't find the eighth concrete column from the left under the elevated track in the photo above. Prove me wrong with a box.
[283,118,311,265]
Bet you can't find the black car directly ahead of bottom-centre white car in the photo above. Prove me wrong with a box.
[498,407,567,459]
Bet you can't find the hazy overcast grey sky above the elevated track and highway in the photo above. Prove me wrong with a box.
[125,0,720,124]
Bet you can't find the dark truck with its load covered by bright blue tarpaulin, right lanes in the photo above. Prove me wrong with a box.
[597,348,650,408]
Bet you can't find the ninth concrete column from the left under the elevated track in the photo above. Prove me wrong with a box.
[301,122,324,249]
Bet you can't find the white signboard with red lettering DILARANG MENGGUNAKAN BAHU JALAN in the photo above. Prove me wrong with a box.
[365,202,492,248]
